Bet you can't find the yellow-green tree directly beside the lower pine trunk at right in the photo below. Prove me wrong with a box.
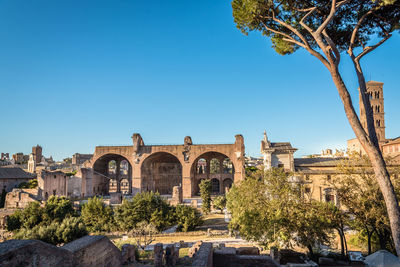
[329,154,400,254]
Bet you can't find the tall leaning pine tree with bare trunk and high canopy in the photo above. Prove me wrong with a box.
[232,0,400,255]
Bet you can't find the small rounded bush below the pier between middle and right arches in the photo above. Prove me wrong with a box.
[175,205,203,232]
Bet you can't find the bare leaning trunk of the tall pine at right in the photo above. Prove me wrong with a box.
[330,67,400,255]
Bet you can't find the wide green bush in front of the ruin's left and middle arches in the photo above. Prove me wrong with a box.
[115,192,175,231]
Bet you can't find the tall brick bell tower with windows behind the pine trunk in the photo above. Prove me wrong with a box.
[360,81,386,144]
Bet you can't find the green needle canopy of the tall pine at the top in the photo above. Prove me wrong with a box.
[232,0,400,55]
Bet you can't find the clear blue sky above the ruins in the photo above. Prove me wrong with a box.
[0,0,400,159]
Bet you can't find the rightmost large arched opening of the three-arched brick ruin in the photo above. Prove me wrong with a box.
[190,152,235,195]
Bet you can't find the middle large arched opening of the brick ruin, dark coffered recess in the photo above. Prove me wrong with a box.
[141,152,182,195]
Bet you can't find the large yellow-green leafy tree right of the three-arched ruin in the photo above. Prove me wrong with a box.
[227,168,332,256]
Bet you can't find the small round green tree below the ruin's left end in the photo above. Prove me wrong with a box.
[81,197,114,232]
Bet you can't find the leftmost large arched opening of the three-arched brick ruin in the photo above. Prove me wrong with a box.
[90,154,132,195]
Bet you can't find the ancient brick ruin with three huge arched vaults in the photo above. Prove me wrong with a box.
[79,133,245,198]
